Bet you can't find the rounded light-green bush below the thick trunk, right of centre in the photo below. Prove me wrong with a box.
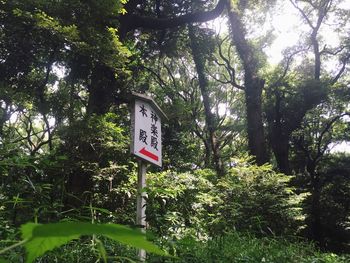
[215,162,300,235]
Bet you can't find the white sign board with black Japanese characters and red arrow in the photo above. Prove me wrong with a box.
[131,99,162,166]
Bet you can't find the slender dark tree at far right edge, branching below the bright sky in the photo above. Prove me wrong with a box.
[293,99,349,244]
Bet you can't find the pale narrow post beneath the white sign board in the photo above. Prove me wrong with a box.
[136,160,147,261]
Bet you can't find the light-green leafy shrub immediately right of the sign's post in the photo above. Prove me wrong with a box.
[146,170,213,239]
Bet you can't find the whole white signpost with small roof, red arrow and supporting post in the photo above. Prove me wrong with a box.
[130,93,167,261]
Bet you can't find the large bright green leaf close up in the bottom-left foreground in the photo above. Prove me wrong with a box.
[21,222,167,262]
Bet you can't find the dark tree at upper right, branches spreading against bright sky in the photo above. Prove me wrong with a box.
[266,0,350,174]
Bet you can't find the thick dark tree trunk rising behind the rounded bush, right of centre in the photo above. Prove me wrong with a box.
[228,1,268,165]
